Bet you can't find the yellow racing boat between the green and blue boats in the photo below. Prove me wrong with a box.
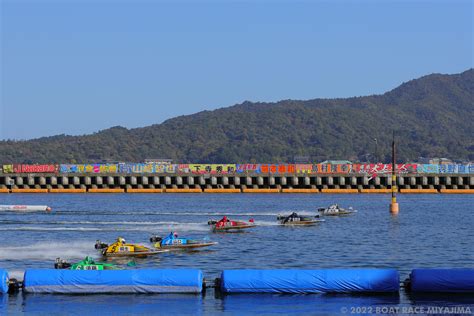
[95,237,168,258]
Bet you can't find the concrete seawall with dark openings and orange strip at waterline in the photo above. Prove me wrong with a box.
[0,174,474,194]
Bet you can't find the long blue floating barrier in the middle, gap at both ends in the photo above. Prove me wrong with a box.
[221,269,400,293]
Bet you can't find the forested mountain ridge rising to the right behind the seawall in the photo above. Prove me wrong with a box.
[0,69,474,163]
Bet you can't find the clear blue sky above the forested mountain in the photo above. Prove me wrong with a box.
[0,0,473,139]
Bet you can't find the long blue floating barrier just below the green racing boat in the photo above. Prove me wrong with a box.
[23,269,203,294]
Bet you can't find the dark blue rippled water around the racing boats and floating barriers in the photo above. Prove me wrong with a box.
[0,194,474,314]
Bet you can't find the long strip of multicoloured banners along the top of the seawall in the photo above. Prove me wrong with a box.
[0,163,474,177]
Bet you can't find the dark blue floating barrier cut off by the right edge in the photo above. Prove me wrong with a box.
[410,269,474,293]
